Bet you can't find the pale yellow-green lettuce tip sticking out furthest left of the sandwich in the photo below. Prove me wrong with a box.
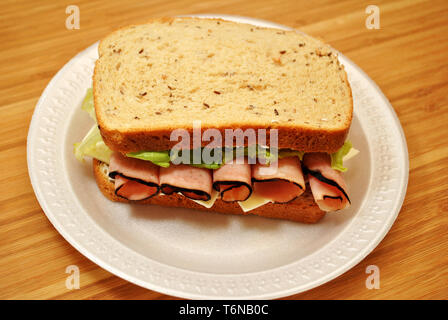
[74,124,112,163]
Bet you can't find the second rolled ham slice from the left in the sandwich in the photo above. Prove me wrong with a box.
[159,164,212,201]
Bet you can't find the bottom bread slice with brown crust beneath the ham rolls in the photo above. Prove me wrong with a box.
[93,159,325,223]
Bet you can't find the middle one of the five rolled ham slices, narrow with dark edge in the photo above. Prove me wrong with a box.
[213,159,252,202]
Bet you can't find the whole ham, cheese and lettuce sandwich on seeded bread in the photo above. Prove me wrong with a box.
[75,18,357,223]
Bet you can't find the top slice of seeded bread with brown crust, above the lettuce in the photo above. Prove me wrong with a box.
[93,18,353,153]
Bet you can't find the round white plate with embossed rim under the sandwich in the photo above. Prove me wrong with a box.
[27,15,408,299]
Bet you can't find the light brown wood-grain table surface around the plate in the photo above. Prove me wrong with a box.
[0,0,448,299]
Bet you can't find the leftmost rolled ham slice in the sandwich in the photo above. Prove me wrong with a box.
[109,152,159,201]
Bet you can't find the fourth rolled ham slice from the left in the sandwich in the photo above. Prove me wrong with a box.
[252,157,305,203]
